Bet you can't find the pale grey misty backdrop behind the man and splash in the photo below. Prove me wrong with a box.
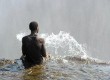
[0,0,110,61]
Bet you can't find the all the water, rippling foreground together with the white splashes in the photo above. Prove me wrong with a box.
[0,31,110,80]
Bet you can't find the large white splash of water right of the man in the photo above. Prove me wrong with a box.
[41,31,87,58]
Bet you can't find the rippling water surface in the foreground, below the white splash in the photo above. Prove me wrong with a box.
[0,59,110,80]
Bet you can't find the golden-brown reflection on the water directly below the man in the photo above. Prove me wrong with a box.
[22,65,45,80]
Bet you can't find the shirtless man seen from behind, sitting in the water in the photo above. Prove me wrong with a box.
[22,21,46,69]
